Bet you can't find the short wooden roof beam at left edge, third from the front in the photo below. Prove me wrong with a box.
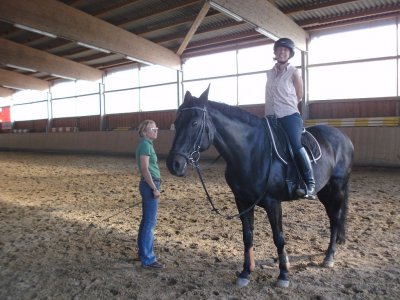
[0,69,50,91]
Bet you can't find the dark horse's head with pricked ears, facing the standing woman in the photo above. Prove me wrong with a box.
[167,87,215,176]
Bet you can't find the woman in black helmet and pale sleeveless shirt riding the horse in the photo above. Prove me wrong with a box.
[265,38,316,200]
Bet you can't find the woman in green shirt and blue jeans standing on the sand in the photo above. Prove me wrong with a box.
[136,120,164,269]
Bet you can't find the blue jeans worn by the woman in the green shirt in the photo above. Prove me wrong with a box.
[138,178,161,266]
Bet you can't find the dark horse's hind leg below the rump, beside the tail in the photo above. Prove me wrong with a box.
[318,178,348,268]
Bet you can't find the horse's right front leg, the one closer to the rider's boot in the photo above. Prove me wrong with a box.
[266,201,290,288]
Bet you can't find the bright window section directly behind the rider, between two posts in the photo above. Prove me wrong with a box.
[183,44,301,105]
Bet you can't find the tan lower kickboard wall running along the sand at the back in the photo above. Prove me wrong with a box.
[0,127,400,167]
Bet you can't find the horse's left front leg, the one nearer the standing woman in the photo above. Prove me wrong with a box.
[236,209,256,287]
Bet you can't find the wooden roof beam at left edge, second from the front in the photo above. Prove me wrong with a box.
[0,38,103,84]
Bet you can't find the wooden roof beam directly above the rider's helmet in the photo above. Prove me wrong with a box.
[210,0,309,51]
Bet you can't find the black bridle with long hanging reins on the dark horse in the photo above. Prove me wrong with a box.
[171,107,272,220]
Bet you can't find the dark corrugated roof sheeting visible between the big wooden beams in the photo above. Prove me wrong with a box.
[0,0,400,86]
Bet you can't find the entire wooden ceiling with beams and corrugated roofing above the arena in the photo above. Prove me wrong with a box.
[0,0,400,97]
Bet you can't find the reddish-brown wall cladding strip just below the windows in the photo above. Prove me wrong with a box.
[9,98,400,132]
